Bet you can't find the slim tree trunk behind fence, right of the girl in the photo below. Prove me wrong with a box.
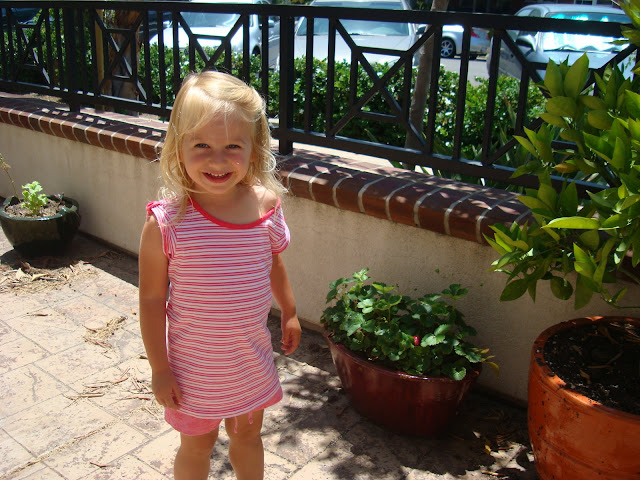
[404,0,449,150]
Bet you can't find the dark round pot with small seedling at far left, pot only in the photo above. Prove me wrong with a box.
[0,197,80,257]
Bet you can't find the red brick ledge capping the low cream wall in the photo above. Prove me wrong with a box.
[0,93,530,243]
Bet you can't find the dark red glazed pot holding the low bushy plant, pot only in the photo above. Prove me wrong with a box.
[325,335,481,437]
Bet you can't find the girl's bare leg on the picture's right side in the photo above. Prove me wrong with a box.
[225,410,264,480]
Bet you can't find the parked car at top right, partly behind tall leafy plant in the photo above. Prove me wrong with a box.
[487,3,630,78]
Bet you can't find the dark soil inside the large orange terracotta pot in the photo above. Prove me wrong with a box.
[544,323,640,415]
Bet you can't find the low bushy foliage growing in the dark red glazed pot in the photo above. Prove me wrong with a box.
[321,269,497,380]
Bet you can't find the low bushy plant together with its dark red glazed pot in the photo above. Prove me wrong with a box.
[321,269,497,436]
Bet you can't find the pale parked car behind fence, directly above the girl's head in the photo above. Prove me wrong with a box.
[149,0,280,67]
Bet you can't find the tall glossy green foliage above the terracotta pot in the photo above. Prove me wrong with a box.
[486,0,640,309]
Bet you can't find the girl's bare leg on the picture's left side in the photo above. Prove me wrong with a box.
[173,428,218,480]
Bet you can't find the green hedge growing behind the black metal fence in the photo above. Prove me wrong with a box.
[140,46,544,165]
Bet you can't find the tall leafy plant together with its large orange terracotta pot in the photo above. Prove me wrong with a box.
[487,0,640,474]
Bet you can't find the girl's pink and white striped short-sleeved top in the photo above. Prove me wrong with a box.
[147,200,289,419]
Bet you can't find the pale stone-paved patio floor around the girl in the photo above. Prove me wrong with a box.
[0,231,537,480]
